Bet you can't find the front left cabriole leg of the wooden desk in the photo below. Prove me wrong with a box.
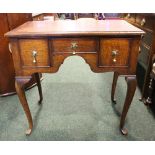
[15,77,33,135]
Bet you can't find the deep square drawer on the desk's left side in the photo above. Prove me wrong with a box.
[19,39,50,67]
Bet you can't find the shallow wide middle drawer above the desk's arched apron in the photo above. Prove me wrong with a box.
[52,38,99,54]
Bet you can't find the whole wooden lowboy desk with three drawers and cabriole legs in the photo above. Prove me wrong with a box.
[5,19,144,134]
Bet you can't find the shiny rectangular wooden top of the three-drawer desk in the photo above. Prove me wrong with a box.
[5,18,144,37]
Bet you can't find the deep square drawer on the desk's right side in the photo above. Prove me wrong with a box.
[99,38,130,67]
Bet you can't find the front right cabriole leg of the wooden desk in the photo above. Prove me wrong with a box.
[120,75,137,135]
